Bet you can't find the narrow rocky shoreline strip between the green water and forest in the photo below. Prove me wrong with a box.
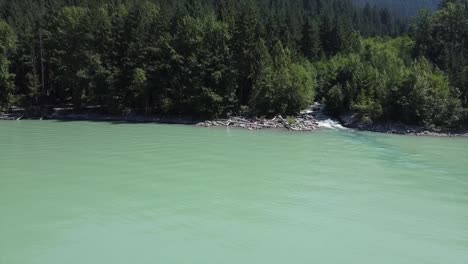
[0,103,468,137]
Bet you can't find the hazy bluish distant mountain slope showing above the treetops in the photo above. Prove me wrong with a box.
[352,0,441,16]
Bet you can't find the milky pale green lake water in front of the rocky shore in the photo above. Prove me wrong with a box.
[0,121,468,264]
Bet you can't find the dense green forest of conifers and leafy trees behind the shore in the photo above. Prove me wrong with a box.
[0,0,468,128]
